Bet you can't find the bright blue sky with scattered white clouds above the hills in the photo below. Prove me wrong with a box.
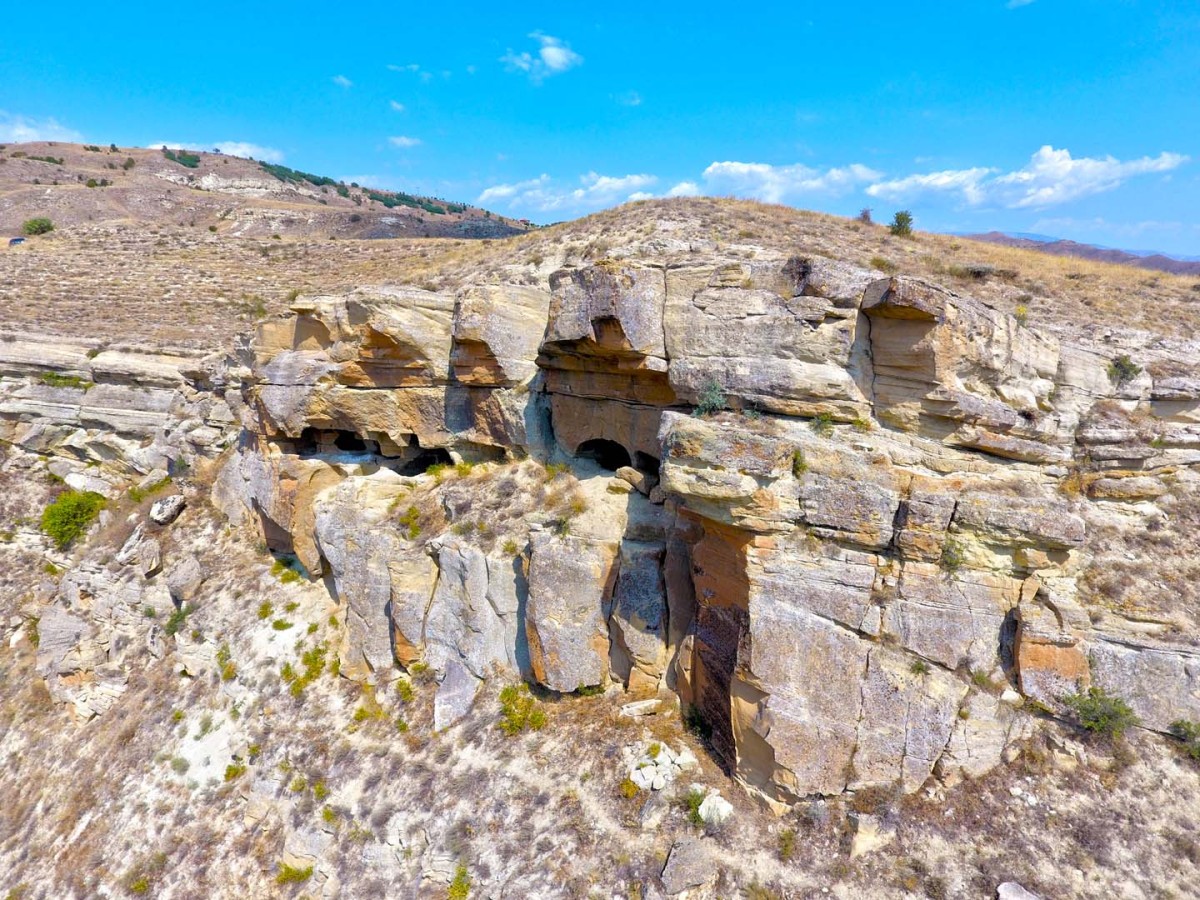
[0,0,1200,254]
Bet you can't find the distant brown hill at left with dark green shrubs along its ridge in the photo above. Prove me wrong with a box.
[0,143,527,239]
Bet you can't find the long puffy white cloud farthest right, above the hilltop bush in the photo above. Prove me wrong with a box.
[866,144,1188,209]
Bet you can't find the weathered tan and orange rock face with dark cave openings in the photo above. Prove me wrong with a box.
[220,248,1200,804]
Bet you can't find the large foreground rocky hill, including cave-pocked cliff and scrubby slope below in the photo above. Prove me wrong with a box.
[0,200,1200,900]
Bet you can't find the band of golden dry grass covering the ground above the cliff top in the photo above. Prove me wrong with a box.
[0,198,1200,348]
